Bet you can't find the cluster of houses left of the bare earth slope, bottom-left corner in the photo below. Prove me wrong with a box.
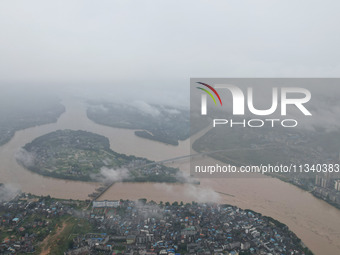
[0,194,73,254]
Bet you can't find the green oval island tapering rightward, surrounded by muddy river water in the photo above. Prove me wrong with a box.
[17,130,184,182]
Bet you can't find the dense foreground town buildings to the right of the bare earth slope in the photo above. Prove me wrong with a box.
[66,201,305,255]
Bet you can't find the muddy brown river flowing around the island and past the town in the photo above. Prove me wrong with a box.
[0,99,340,255]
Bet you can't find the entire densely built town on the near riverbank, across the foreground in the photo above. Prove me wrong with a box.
[0,194,311,255]
